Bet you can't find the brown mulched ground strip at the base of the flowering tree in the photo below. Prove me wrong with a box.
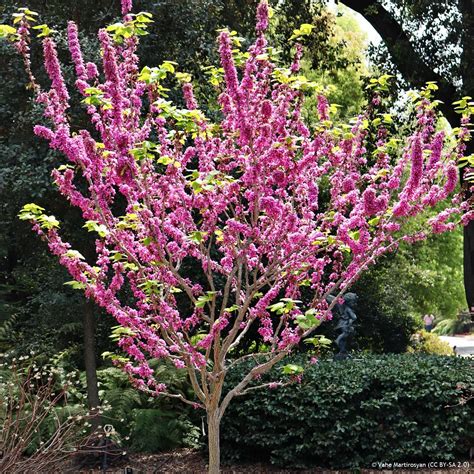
[72,449,474,474]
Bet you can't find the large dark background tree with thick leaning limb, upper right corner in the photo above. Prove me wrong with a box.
[343,0,474,308]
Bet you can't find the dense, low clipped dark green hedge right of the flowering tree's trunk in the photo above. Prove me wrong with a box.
[221,354,474,469]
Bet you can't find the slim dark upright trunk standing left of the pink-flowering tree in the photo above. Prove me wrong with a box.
[83,301,100,429]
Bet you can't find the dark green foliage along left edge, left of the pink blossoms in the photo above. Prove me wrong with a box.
[0,0,118,360]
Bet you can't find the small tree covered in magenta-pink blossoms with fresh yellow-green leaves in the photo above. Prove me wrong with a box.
[2,1,473,473]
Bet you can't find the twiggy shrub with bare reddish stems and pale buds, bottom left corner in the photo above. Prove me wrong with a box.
[0,353,95,474]
